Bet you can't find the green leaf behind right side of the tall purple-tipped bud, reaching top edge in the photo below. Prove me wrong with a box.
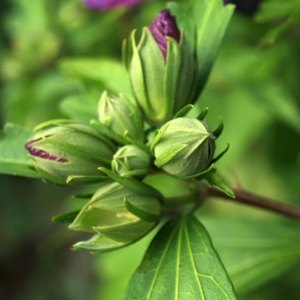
[169,0,234,91]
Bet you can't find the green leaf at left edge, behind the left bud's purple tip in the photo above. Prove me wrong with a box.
[0,123,41,178]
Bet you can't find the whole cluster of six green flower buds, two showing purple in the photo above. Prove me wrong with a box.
[25,10,227,251]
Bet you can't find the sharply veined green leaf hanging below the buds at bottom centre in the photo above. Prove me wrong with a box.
[123,215,236,300]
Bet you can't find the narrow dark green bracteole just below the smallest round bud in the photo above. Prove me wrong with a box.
[99,167,164,204]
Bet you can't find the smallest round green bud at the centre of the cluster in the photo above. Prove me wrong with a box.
[112,145,151,176]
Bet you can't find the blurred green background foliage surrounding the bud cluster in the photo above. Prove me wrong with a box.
[0,0,300,300]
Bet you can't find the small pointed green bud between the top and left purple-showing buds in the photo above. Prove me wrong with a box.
[98,91,145,142]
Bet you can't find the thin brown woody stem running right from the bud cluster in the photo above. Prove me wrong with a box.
[204,186,300,220]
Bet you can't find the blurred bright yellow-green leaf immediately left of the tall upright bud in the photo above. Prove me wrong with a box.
[60,59,132,99]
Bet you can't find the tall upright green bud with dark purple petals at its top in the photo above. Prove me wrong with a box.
[127,10,198,127]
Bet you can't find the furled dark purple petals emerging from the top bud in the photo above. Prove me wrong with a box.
[149,9,180,59]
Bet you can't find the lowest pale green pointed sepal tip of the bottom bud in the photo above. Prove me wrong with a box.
[72,234,128,254]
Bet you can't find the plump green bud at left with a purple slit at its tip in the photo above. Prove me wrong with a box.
[25,121,116,185]
